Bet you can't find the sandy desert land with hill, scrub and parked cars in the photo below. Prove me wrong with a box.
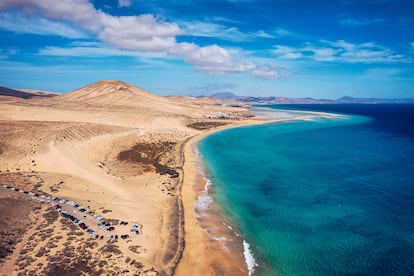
[0,81,258,275]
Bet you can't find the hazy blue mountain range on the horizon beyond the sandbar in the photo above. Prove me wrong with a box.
[211,92,414,104]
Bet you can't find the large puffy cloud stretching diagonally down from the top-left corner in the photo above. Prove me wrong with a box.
[0,0,282,76]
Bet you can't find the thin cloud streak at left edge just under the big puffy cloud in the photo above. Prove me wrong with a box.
[0,12,87,38]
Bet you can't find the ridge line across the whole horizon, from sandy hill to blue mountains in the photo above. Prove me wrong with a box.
[0,80,414,107]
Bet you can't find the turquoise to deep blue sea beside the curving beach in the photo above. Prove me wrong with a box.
[199,105,414,275]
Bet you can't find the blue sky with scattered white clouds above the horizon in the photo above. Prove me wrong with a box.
[0,0,414,99]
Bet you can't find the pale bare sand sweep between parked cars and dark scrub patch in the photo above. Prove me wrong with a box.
[34,129,176,272]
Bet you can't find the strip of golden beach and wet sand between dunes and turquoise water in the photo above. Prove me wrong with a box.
[177,121,264,275]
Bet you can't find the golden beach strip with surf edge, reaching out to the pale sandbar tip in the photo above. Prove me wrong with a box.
[175,109,346,275]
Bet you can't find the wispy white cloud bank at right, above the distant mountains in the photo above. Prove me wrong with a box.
[273,40,412,63]
